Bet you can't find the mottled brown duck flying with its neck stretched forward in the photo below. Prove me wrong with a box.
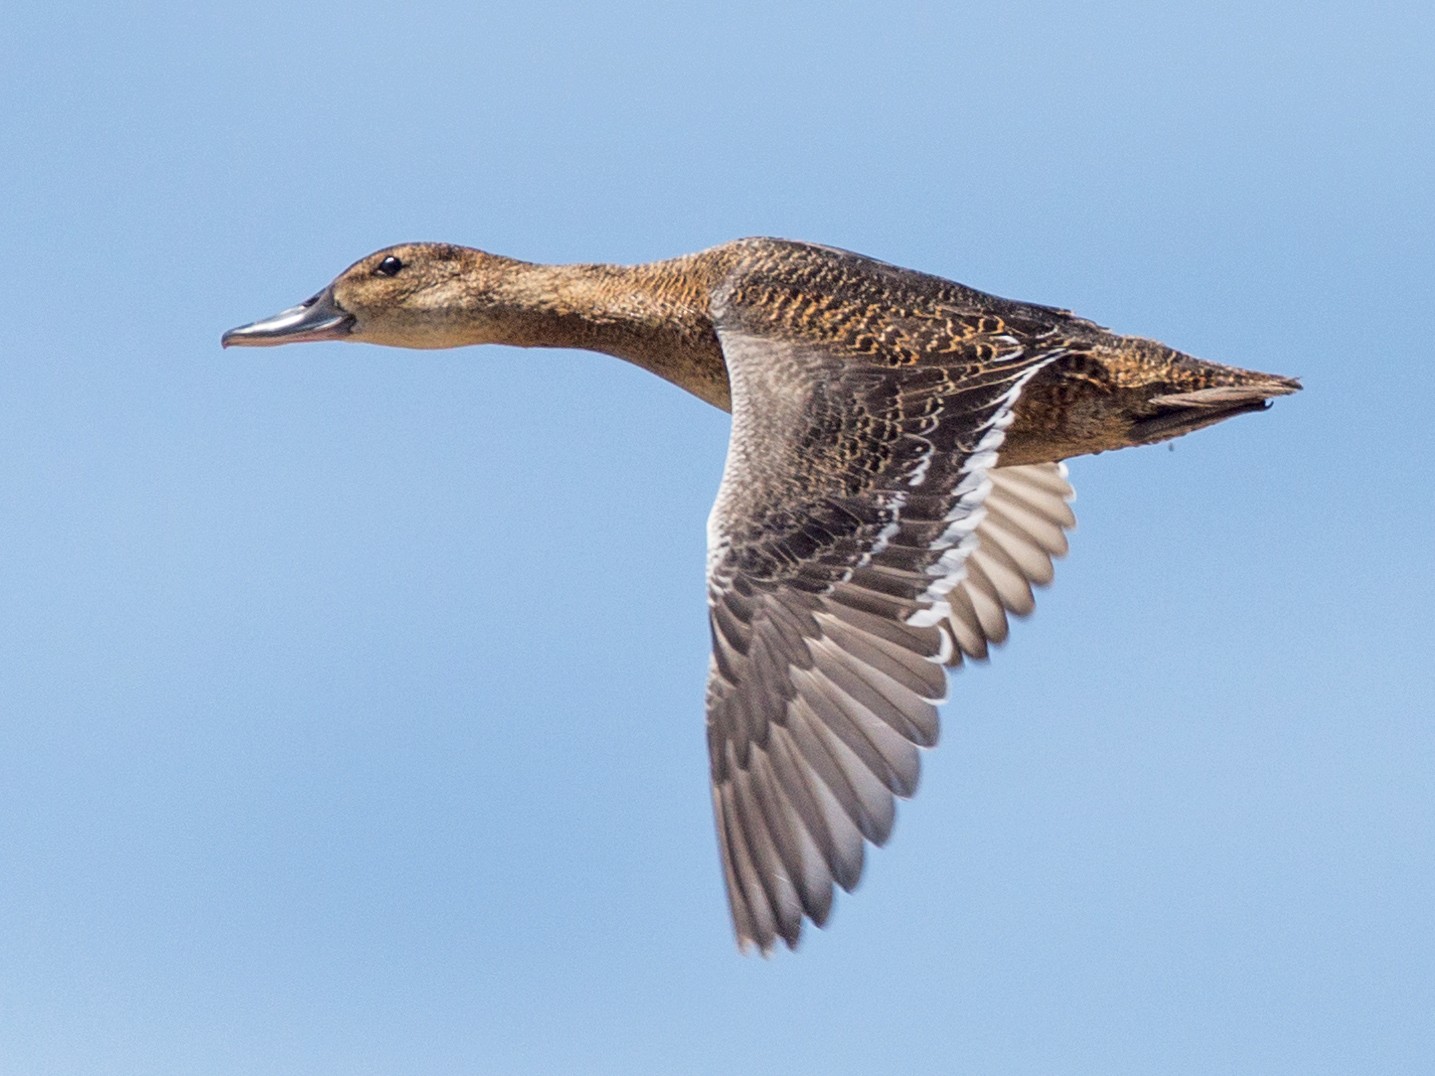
[221,238,1302,955]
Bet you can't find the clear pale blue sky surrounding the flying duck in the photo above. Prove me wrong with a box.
[0,0,1435,1076]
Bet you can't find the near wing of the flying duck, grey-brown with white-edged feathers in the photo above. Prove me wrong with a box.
[707,261,1058,951]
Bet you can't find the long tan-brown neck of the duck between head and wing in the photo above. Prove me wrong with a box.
[484,257,729,409]
